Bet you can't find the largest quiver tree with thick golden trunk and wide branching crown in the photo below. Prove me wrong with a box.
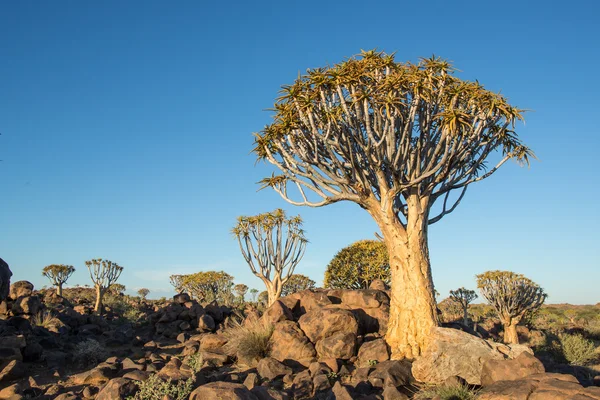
[254,51,531,359]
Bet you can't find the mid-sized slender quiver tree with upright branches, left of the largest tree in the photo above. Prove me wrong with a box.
[232,209,308,306]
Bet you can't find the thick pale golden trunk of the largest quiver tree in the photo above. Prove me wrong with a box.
[372,196,439,359]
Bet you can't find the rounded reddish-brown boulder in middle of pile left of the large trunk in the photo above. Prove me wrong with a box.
[298,308,358,343]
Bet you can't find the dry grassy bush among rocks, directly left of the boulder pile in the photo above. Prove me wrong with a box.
[223,320,273,367]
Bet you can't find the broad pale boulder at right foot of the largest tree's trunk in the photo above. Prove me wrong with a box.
[412,328,533,385]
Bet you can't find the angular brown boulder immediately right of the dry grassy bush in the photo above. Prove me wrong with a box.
[271,321,316,361]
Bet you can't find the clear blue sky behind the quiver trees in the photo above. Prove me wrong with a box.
[0,0,600,303]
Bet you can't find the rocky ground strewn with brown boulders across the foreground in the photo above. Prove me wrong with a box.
[0,258,600,400]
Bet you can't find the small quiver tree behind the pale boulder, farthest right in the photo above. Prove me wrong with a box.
[477,271,548,344]
